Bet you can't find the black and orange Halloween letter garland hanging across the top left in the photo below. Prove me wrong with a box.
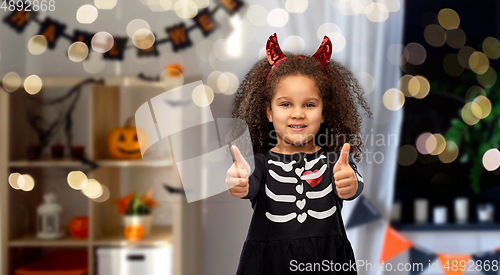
[3,0,243,60]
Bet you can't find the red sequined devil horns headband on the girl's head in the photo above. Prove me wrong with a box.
[266,33,332,86]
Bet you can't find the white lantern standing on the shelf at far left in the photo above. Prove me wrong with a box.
[37,193,64,239]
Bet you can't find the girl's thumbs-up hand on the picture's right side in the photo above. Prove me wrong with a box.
[333,143,358,199]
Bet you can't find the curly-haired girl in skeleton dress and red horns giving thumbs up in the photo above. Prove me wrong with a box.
[226,34,371,275]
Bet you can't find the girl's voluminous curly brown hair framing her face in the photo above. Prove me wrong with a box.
[232,53,372,162]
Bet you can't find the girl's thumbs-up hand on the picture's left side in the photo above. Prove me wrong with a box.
[226,145,251,198]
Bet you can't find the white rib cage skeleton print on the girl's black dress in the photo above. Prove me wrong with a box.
[265,155,337,223]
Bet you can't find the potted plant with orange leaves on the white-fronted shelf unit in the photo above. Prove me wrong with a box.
[115,189,158,241]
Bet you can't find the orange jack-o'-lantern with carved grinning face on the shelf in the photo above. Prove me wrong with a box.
[108,118,147,159]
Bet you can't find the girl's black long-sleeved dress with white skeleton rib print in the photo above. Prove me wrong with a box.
[236,148,364,275]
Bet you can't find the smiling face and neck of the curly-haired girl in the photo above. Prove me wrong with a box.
[267,75,325,152]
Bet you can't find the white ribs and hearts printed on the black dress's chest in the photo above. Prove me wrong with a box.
[264,152,337,224]
